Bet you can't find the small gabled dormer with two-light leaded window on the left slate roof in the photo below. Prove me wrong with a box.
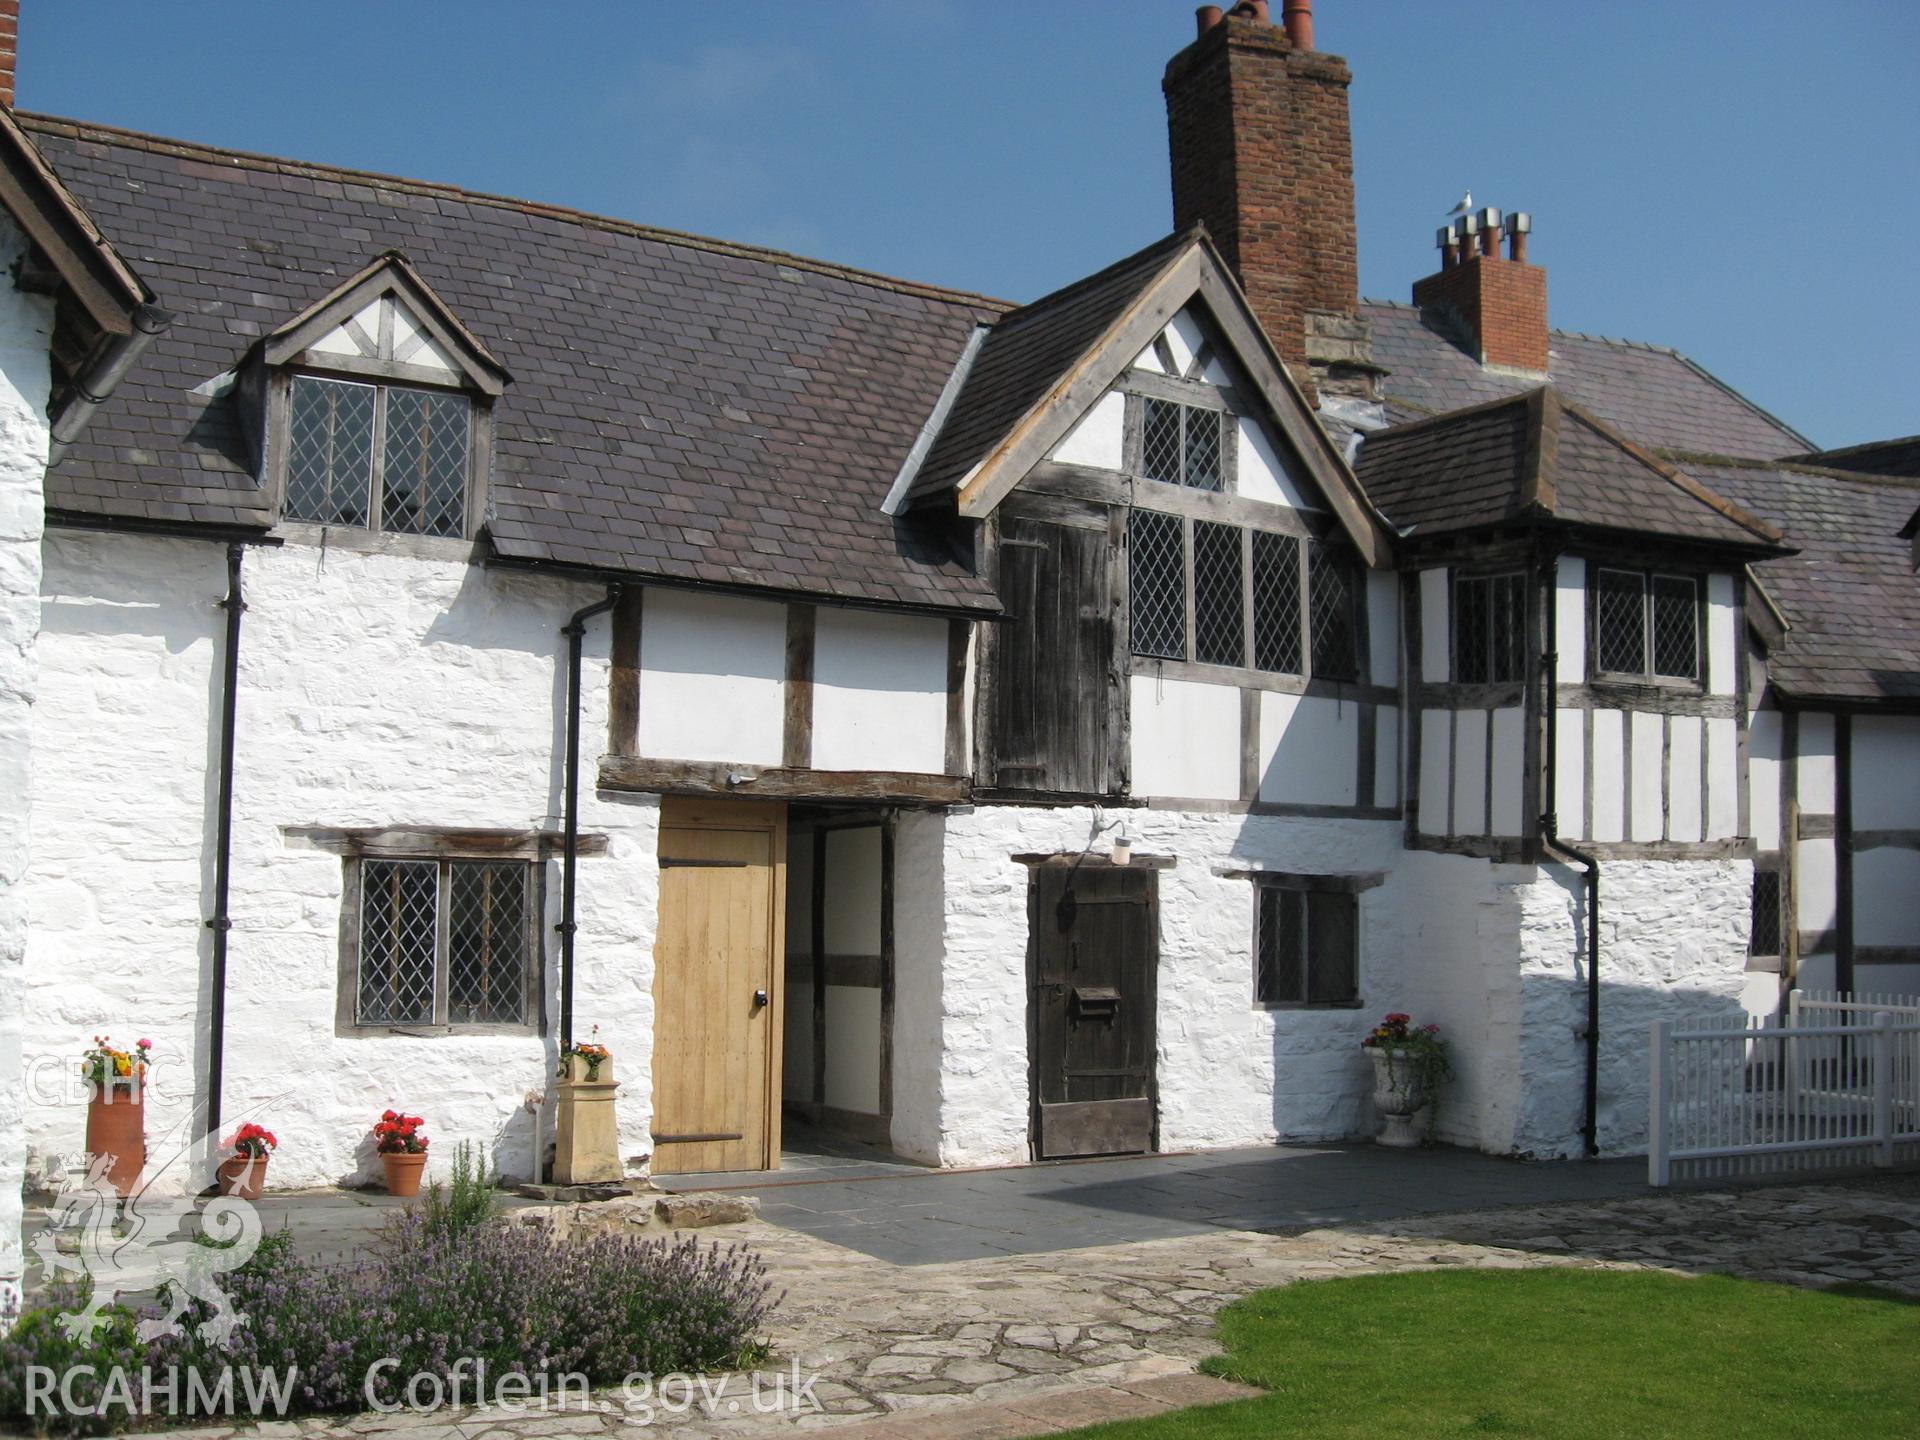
[240,252,509,540]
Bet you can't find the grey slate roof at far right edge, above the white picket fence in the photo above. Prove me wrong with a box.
[1686,463,1920,705]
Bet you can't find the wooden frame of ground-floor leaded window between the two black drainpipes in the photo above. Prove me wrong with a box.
[328,843,547,1039]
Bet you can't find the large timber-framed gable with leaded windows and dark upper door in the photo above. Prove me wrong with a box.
[891,230,1398,812]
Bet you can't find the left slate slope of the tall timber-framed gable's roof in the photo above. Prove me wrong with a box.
[906,234,1192,501]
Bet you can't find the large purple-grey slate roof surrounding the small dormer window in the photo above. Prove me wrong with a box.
[21,117,1006,611]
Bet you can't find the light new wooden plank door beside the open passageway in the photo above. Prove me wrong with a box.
[653,816,783,1175]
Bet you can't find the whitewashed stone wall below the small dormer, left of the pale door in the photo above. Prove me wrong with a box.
[25,532,659,1187]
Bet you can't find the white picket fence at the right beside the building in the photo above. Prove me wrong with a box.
[1647,991,1920,1185]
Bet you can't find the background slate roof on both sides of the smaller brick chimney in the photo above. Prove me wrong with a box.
[1361,300,1812,461]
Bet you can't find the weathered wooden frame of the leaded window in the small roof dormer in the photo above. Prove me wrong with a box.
[267,365,493,557]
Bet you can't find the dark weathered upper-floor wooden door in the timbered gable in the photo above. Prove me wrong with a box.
[983,513,1119,795]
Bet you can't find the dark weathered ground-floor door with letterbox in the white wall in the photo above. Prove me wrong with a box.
[1027,858,1160,1160]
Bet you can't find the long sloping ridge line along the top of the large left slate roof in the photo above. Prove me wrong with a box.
[15,111,1018,315]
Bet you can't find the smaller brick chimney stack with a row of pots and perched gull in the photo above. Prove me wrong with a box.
[1413,207,1548,374]
